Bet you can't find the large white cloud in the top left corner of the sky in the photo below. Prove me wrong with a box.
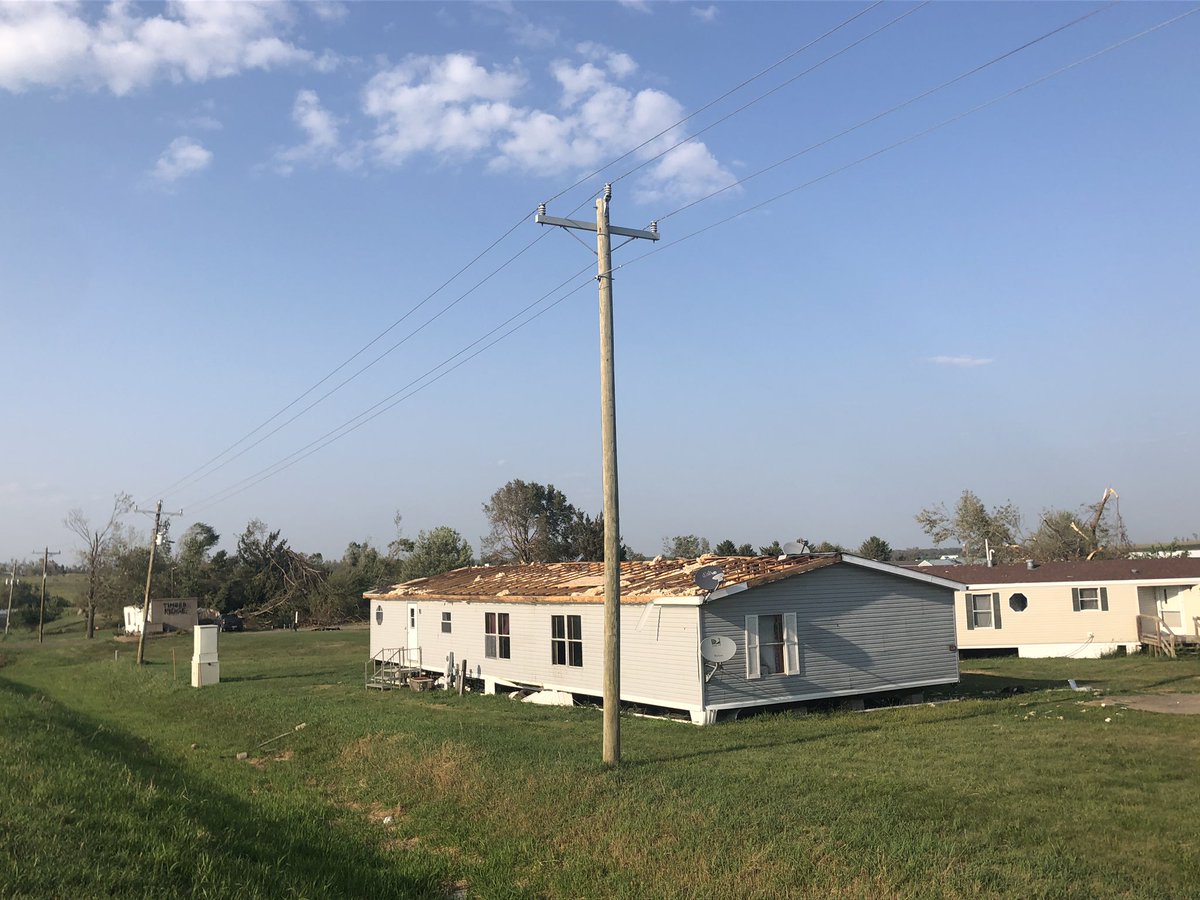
[0,0,331,96]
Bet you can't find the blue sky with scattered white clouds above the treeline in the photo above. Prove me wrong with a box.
[0,2,1200,559]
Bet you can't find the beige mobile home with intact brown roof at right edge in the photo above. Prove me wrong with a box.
[940,558,1200,656]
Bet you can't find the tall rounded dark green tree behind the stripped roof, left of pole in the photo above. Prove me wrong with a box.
[484,479,577,563]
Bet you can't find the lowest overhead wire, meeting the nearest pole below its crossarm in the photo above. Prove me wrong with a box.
[174,6,1200,509]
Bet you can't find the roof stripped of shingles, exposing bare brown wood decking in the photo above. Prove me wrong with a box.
[364,553,841,604]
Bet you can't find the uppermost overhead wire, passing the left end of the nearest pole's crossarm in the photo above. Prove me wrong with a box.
[146,0,902,511]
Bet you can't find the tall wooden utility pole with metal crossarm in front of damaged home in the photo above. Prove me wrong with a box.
[534,185,659,766]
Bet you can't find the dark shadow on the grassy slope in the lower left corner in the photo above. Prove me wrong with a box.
[0,678,445,898]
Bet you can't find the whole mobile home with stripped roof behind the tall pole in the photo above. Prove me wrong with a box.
[365,553,959,724]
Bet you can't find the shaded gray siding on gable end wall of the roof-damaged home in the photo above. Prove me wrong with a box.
[702,563,959,708]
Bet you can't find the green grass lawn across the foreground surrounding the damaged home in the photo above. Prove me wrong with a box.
[0,630,1200,898]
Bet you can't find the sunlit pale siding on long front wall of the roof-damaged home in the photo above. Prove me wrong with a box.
[371,599,702,709]
